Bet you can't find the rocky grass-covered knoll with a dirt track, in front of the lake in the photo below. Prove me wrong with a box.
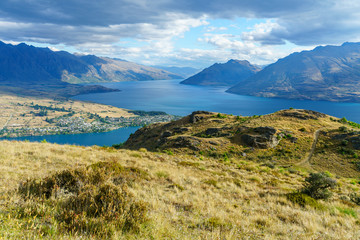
[124,109,360,177]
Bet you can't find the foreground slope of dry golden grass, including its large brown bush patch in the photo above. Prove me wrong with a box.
[0,138,360,239]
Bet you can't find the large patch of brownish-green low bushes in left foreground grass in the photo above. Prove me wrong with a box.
[12,162,148,238]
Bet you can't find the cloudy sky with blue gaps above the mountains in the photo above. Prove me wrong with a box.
[0,0,360,68]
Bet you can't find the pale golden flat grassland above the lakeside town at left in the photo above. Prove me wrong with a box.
[0,94,134,130]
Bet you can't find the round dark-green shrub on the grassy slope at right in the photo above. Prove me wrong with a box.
[302,173,336,200]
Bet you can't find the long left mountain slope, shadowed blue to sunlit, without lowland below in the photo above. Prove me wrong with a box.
[0,42,179,84]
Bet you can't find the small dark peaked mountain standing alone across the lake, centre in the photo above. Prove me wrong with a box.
[181,59,260,86]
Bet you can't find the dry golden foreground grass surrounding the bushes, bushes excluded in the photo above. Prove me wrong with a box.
[0,141,360,239]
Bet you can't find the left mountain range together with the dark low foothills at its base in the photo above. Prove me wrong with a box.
[0,42,180,97]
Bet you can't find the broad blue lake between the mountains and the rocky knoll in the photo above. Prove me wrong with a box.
[74,80,360,123]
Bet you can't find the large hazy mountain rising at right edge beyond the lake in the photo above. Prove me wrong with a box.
[228,43,360,102]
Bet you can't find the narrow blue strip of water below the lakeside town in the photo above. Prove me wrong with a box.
[2,127,139,146]
